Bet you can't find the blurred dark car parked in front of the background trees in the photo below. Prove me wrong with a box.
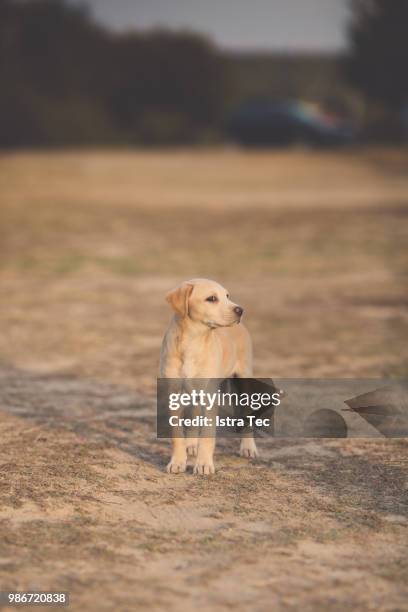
[226,101,354,147]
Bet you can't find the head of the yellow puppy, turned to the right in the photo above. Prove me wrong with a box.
[166,278,244,328]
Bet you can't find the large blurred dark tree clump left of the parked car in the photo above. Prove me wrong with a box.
[0,0,226,146]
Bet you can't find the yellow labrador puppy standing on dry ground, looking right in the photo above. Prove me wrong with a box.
[160,278,257,474]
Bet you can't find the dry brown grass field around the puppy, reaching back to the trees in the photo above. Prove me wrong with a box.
[0,150,408,612]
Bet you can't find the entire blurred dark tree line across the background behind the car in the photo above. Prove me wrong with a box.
[0,0,408,147]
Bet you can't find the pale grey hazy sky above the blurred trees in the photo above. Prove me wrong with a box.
[77,0,348,50]
